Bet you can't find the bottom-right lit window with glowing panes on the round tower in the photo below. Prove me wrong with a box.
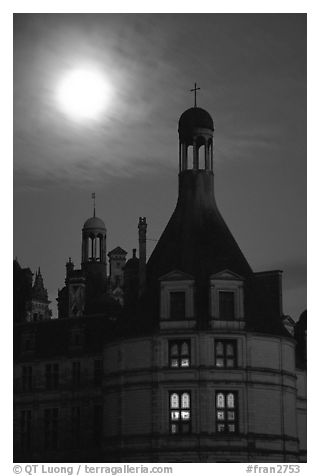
[216,391,237,433]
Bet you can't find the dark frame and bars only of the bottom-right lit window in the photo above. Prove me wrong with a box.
[215,390,239,436]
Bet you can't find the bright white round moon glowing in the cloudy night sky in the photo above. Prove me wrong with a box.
[57,69,110,120]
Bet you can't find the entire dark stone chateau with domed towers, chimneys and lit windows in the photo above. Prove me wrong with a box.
[14,100,306,462]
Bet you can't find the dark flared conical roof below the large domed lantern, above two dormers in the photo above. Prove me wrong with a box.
[147,170,252,284]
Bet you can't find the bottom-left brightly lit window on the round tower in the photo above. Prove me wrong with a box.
[170,391,191,434]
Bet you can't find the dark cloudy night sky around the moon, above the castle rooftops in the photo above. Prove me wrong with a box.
[14,14,307,319]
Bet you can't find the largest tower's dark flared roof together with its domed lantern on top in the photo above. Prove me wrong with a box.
[147,106,252,325]
